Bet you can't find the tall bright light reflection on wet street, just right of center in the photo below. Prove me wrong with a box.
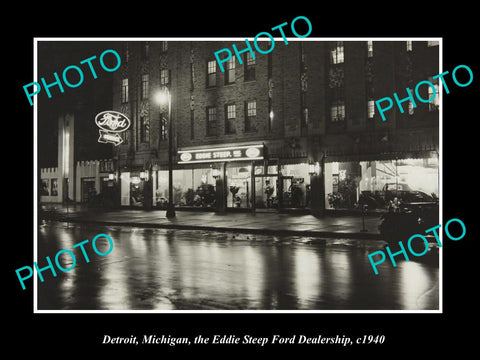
[294,249,321,308]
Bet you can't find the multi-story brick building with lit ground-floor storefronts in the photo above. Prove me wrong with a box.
[113,39,440,211]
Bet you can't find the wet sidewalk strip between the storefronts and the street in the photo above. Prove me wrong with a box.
[40,204,381,240]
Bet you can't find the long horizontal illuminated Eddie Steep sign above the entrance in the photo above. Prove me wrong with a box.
[178,144,264,164]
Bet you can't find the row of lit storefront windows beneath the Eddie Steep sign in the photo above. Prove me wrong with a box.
[120,161,316,210]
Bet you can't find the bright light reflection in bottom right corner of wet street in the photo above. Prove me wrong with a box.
[396,261,435,310]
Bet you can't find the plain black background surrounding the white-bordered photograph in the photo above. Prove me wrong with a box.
[6,1,479,358]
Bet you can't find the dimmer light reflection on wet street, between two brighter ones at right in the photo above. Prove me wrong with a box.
[327,250,352,301]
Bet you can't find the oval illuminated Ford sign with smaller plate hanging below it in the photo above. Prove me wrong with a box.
[95,111,131,146]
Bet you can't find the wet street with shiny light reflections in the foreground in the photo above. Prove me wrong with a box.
[36,222,439,310]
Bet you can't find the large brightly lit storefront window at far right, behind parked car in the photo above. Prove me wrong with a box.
[325,157,439,210]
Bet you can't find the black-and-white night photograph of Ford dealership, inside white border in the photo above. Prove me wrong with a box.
[33,37,440,311]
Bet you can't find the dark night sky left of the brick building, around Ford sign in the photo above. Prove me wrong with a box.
[36,40,114,168]
